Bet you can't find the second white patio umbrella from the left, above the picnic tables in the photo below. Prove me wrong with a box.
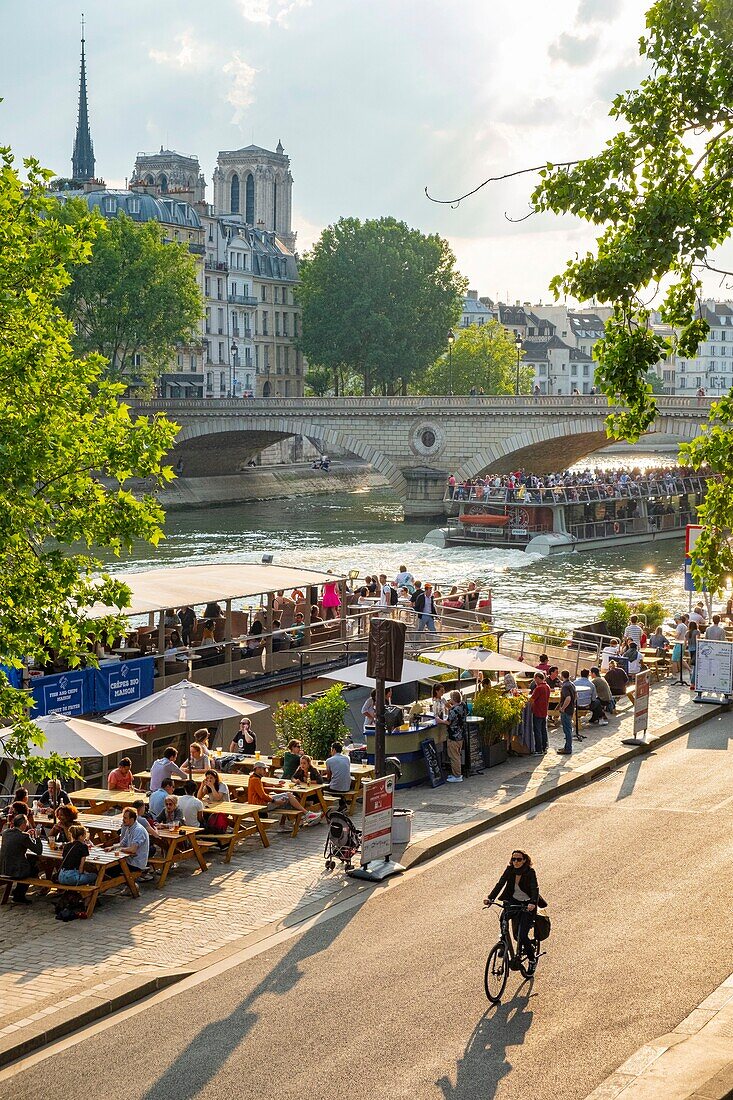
[107,680,269,726]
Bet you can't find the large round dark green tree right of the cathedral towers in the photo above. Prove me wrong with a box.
[298,218,466,394]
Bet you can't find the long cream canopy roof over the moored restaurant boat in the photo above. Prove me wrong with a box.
[89,562,346,618]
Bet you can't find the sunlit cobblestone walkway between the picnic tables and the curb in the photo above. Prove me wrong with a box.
[0,682,710,1064]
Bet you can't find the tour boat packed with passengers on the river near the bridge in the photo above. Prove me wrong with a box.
[425,476,708,557]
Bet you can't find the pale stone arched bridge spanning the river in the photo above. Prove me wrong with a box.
[135,396,710,518]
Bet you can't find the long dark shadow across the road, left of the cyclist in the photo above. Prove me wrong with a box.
[142,906,359,1100]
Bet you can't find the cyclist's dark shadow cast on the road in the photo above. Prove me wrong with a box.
[436,982,533,1100]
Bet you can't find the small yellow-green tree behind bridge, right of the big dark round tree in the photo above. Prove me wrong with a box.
[413,320,534,395]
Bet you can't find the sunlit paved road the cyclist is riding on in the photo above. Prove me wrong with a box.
[6,716,733,1100]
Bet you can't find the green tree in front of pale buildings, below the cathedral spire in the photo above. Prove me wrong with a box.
[61,199,203,384]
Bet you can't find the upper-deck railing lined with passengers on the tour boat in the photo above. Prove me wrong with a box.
[444,477,710,505]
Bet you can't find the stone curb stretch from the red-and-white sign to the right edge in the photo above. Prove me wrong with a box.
[400,705,729,869]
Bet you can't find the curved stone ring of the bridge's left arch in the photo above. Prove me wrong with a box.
[174,416,407,501]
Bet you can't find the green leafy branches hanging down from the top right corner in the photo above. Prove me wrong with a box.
[533,0,733,441]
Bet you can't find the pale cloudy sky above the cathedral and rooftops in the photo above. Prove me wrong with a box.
[0,0,733,303]
